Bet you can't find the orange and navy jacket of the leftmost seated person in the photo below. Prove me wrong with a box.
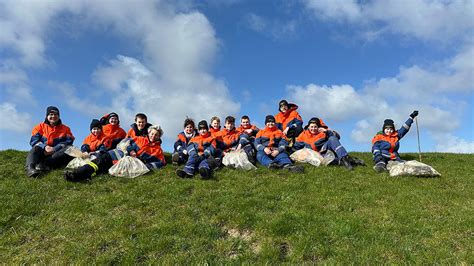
[30,120,74,151]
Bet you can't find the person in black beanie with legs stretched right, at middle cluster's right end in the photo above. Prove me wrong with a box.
[294,117,363,170]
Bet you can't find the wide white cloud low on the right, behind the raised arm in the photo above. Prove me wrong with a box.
[287,46,474,149]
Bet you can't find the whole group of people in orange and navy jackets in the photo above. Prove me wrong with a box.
[26,100,418,181]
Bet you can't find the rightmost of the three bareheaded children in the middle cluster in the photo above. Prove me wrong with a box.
[217,116,257,165]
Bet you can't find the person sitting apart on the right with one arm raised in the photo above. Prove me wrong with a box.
[372,111,418,173]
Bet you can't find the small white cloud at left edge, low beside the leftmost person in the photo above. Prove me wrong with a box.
[0,102,32,133]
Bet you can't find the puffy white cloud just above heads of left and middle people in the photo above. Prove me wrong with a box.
[88,56,240,139]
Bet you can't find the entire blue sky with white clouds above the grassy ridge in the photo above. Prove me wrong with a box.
[0,0,474,153]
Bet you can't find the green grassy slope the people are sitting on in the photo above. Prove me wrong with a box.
[0,150,474,265]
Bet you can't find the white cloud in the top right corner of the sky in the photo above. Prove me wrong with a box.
[305,0,474,42]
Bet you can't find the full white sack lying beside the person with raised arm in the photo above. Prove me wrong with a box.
[387,160,441,177]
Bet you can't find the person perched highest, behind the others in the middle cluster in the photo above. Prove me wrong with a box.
[275,100,303,147]
